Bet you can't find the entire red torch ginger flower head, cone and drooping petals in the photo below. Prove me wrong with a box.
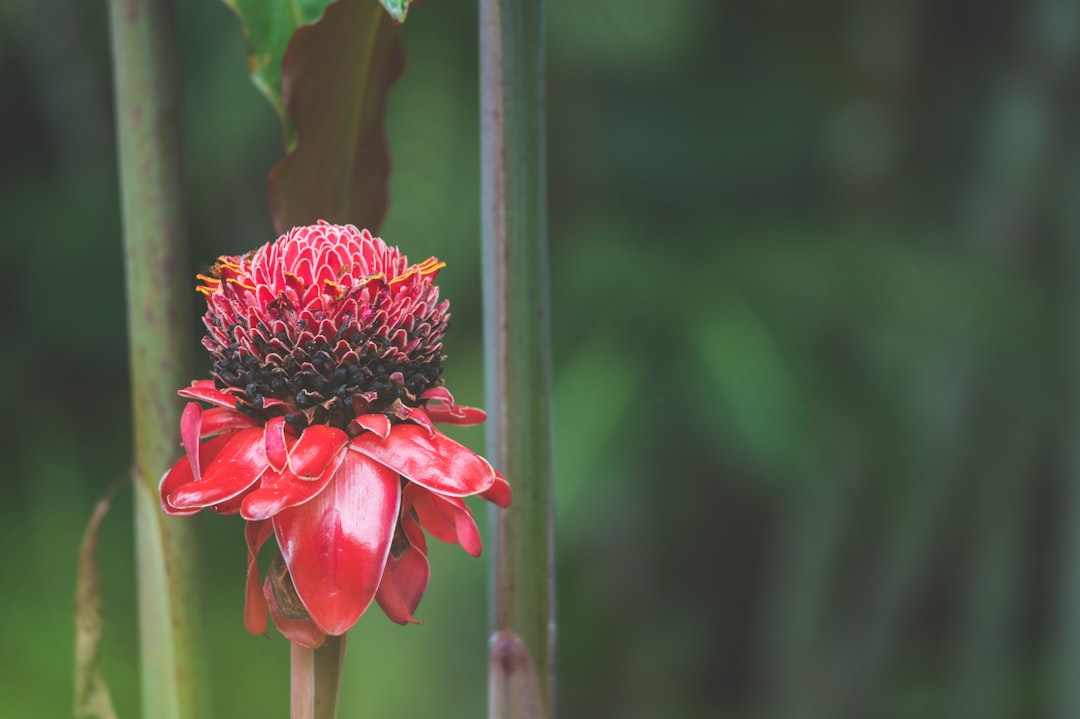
[160,222,510,647]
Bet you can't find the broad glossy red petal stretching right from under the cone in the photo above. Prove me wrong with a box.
[349,424,495,497]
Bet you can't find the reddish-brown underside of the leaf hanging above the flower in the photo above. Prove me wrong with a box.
[267,0,404,233]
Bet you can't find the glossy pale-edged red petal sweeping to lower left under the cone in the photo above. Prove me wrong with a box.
[168,426,267,510]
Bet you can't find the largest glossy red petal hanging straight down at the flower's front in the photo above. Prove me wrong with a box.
[273,451,401,635]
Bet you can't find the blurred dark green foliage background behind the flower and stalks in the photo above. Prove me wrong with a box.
[0,0,1080,719]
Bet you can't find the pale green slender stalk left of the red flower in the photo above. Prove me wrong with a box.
[109,0,208,719]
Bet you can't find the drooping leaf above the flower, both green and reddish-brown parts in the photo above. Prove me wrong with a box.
[225,0,410,232]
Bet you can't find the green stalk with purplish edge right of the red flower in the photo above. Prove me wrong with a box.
[480,0,555,719]
